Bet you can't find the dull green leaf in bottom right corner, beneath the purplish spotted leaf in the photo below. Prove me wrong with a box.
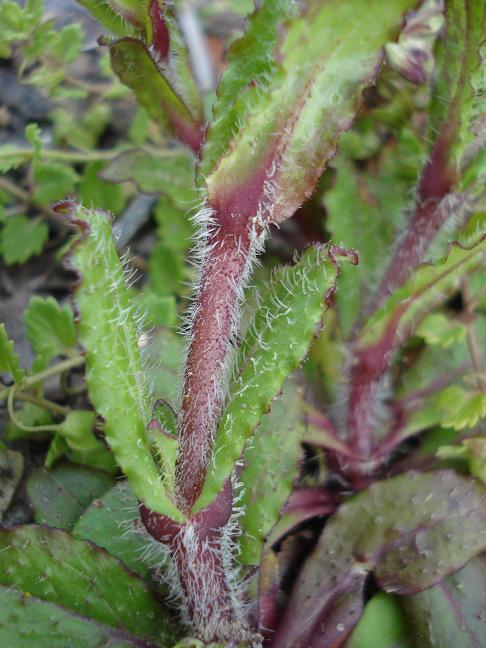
[401,558,486,648]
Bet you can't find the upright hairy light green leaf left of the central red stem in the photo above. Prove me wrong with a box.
[60,205,182,520]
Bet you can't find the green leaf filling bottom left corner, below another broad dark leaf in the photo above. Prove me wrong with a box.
[0,587,152,648]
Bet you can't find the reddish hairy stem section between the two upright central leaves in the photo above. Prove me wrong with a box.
[176,228,250,514]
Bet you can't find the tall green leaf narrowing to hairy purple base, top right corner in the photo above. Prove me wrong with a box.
[370,0,486,312]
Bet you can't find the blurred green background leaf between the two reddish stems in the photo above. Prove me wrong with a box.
[324,129,423,337]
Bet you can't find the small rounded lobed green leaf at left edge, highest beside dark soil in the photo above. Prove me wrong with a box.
[0,216,49,265]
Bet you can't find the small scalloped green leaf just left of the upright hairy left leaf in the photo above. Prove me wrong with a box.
[24,295,76,364]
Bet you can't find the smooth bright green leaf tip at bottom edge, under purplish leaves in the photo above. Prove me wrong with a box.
[346,592,412,648]
